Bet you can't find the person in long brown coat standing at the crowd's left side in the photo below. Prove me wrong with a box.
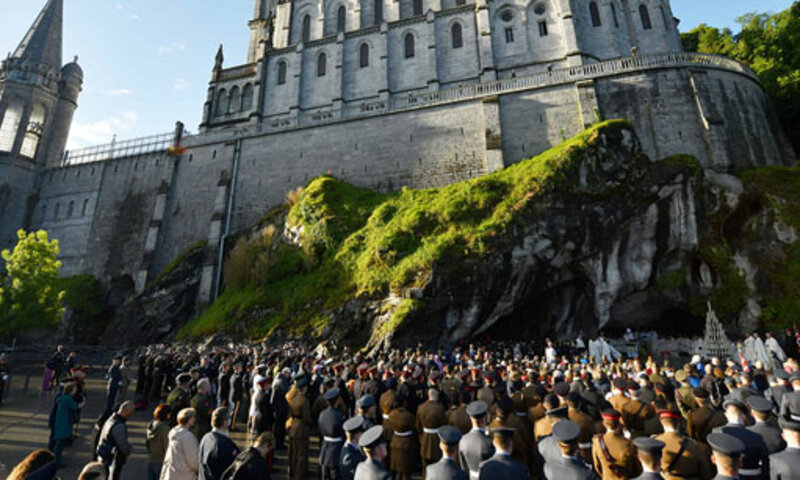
[286,372,311,480]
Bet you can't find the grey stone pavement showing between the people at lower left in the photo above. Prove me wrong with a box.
[0,369,319,480]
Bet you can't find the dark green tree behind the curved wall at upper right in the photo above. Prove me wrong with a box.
[681,2,800,152]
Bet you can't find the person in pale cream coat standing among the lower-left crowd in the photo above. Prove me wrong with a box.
[161,408,200,480]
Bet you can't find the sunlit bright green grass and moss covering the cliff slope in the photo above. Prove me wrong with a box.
[179,120,631,338]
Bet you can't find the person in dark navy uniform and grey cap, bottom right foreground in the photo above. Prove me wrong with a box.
[709,399,769,480]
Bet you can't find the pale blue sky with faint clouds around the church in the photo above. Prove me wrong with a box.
[0,0,792,148]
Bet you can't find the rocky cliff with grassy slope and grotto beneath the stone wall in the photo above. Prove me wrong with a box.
[101,121,800,346]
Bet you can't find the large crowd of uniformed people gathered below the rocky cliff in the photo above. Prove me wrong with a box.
[4,335,800,480]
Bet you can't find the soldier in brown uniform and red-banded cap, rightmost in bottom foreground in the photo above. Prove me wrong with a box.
[652,409,714,480]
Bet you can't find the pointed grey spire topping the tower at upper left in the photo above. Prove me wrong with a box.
[11,0,64,69]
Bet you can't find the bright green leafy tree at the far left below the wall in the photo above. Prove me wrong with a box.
[0,230,64,336]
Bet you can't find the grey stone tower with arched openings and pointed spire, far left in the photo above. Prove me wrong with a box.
[0,0,83,249]
